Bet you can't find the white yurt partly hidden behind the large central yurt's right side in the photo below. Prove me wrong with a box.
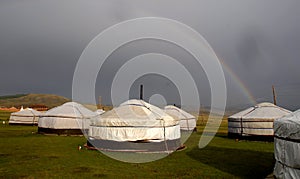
[164,105,197,131]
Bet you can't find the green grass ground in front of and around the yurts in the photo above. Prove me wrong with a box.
[0,122,274,178]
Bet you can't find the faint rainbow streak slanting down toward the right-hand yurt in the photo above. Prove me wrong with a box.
[218,57,257,105]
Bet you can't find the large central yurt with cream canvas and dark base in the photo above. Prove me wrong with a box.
[88,100,180,152]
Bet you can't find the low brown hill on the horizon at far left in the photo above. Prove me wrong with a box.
[0,94,70,108]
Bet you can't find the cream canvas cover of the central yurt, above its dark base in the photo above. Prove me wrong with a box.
[89,100,180,141]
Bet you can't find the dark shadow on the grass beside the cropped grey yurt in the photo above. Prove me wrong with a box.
[187,146,275,178]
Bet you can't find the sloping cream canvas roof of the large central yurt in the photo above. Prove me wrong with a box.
[96,99,178,126]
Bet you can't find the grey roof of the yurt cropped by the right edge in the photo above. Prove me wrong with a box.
[274,109,300,140]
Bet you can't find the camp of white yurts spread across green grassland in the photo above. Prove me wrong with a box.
[0,94,300,178]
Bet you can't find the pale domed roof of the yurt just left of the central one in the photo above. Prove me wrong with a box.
[43,102,97,117]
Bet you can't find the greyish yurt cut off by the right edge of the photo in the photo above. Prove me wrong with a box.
[274,109,300,178]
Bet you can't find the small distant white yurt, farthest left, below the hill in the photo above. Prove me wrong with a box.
[9,108,42,125]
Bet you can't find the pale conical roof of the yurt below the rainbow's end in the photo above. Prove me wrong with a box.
[229,102,291,119]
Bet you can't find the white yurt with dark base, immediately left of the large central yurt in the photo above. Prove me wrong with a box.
[38,102,98,135]
